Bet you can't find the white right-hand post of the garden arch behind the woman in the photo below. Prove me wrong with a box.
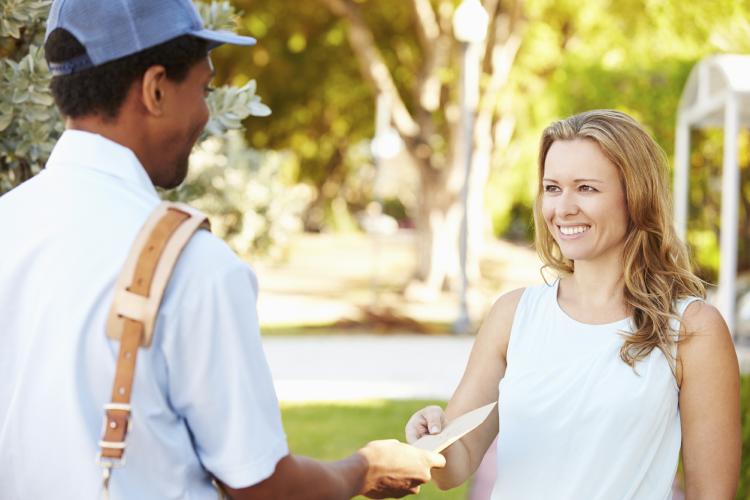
[717,94,740,336]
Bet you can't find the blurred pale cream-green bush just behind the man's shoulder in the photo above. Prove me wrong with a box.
[166,130,313,260]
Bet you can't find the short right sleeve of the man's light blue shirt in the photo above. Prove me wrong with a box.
[162,254,288,488]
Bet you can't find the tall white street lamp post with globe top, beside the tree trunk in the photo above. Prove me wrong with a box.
[453,0,489,334]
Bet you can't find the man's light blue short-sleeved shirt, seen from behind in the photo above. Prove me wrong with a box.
[0,130,288,500]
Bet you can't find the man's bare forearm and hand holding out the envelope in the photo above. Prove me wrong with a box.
[222,440,445,500]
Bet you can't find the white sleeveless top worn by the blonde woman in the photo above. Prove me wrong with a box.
[492,280,698,500]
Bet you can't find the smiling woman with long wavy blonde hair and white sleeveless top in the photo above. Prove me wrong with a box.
[406,110,741,500]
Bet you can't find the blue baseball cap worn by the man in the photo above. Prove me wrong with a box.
[44,0,255,76]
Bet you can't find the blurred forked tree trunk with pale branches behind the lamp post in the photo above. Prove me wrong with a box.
[319,0,522,295]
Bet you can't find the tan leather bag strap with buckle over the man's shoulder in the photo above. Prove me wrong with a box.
[98,202,210,484]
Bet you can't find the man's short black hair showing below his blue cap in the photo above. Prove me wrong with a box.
[44,28,208,119]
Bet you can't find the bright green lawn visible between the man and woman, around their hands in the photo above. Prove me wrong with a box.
[281,400,468,500]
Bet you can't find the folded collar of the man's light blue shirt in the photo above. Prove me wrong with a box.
[46,130,159,198]
